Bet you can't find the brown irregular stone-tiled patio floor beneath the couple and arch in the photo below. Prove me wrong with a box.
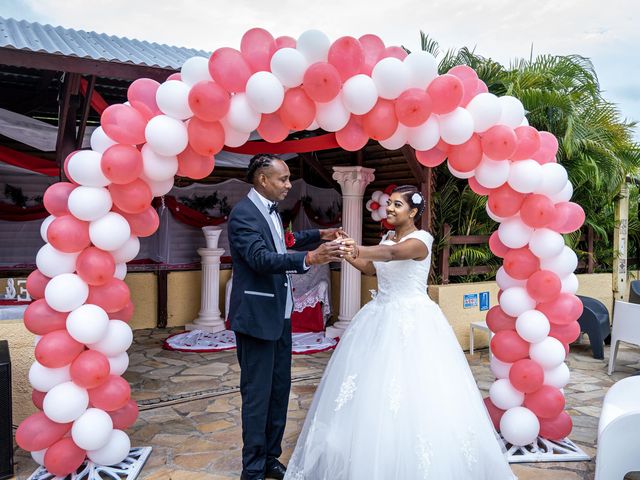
[16,329,640,480]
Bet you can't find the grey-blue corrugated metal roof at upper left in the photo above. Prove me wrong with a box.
[0,17,209,70]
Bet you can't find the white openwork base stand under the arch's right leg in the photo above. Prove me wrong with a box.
[500,437,591,463]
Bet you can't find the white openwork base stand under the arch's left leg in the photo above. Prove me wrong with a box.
[29,447,151,480]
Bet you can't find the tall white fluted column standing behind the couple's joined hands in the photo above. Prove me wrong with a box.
[326,167,375,338]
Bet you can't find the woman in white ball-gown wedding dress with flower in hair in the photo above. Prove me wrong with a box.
[285,186,515,480]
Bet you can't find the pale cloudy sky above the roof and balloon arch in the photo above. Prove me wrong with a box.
[0,0,640,141]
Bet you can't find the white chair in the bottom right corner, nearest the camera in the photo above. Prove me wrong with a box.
[595,377,640,480]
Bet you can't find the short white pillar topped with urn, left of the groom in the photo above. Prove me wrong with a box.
[186,226,225,333]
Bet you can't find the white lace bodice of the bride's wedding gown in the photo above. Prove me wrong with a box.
[373,230,433,298]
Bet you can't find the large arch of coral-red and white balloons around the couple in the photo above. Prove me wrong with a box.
[16,28,584,476]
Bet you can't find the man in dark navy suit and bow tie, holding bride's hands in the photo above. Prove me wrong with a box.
[228,155,345,480]
